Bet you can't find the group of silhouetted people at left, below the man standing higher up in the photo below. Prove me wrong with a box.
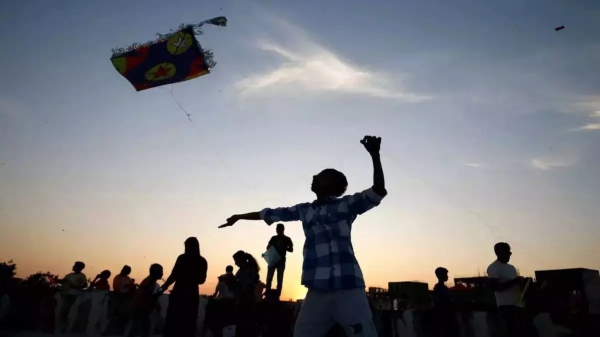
[58,237,270,337]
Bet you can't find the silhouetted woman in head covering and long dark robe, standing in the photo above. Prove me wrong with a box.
[162,237,208,337]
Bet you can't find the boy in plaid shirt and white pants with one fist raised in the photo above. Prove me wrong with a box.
[220,136,387,337]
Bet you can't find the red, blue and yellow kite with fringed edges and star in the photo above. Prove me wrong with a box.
[110,16,227,91]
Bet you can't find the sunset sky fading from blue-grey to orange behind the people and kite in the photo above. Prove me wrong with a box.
[0,0,600,299]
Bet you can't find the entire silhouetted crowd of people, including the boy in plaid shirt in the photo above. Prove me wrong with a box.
[1,136,600,337]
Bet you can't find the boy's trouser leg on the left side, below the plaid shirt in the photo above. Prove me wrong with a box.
[294,290,333,337]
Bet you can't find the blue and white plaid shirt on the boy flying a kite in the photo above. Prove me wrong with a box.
[260,188,383,290]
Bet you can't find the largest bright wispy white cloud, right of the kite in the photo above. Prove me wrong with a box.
[236,22,431,102]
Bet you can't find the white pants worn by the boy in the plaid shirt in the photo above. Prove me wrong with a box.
[294,289,377,337]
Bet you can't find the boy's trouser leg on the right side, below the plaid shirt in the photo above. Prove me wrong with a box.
[332,288,377,337]
